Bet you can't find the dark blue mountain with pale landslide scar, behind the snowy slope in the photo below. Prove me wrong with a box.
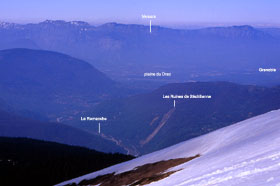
[76,82,280,155]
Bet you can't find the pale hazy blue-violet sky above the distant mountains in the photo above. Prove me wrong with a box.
[0,0,280,25]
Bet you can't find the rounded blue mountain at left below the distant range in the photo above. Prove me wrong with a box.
[0,49,119,121]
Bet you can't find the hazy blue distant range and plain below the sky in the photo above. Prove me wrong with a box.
[0,20,280,84]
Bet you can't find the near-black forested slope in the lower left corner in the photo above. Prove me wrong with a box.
[0,137,133,186]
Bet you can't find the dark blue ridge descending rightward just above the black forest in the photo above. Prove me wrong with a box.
[0,105,126,153]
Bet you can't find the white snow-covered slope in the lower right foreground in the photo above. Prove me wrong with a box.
[58,110,280,186]
